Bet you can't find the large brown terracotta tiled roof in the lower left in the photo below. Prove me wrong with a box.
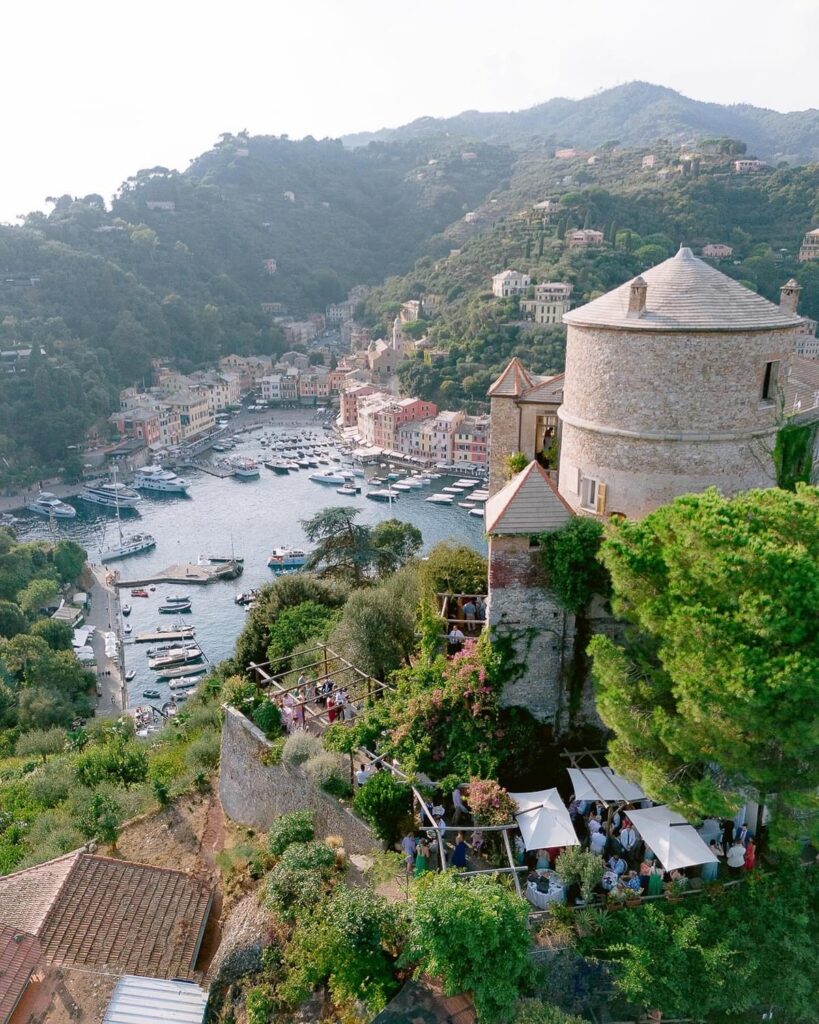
[0,852,212,978]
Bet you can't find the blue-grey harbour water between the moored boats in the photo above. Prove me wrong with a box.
[18,426,486,705]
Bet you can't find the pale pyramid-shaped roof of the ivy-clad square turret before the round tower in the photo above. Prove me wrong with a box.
[483,462,573,535]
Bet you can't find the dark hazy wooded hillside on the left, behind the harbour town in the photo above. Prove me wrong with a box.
[0,135,511,480]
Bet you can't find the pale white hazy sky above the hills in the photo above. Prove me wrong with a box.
[0,0,819,221]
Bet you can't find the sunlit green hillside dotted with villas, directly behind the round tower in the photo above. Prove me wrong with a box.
[365,147,819,406]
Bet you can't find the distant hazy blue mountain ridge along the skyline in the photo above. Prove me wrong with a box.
[341,81,819,162]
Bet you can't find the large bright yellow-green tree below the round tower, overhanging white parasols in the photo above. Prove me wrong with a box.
[590,484,819,839]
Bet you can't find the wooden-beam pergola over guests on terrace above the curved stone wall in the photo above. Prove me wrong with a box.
[248,643,392,734]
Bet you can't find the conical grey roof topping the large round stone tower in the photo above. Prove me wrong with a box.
[563,248,803,332]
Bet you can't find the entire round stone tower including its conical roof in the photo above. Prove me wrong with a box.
[558,248,803,518]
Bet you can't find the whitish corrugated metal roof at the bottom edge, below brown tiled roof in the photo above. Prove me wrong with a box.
[102,975,208,1024]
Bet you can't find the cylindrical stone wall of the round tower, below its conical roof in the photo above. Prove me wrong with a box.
[559,326,796,518]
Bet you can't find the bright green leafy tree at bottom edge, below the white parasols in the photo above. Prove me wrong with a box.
[400,871,531,1024]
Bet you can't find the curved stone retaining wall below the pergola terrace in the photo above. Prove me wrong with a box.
[219,708,380,853]
